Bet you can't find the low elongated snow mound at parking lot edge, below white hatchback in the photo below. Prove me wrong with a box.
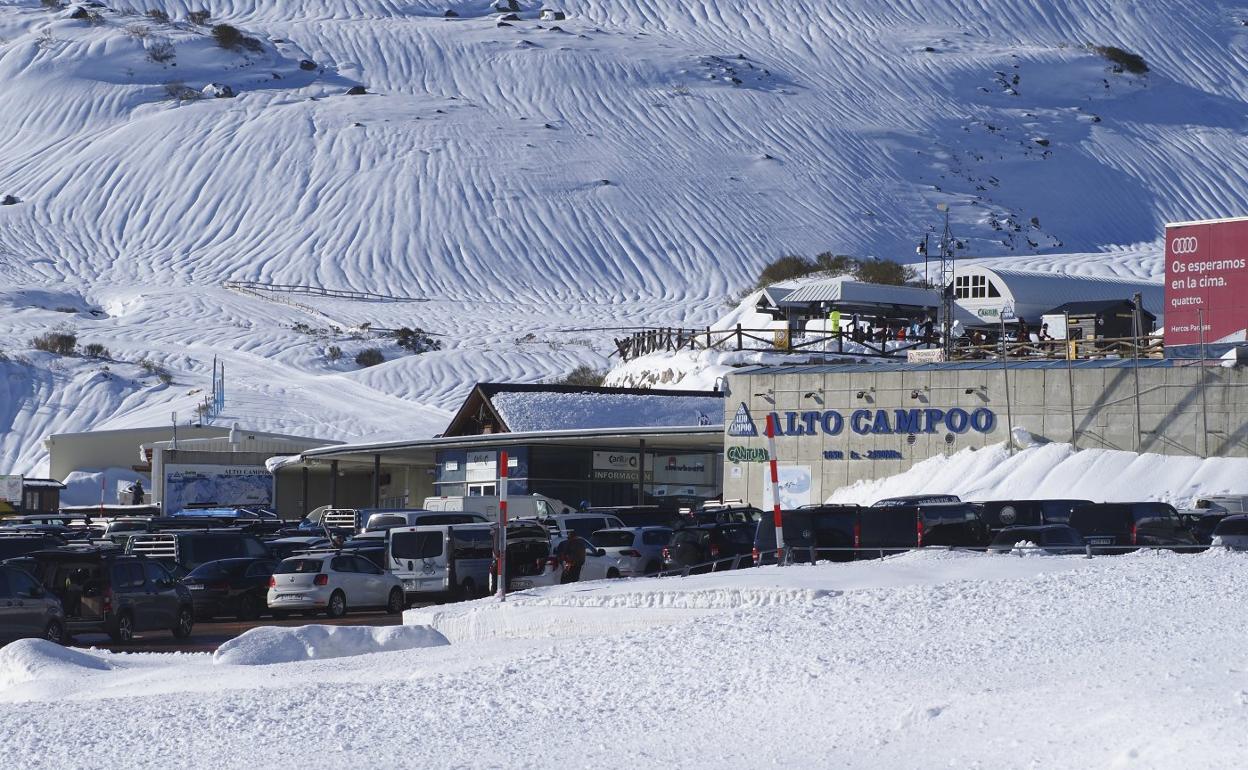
[212,625,449,665]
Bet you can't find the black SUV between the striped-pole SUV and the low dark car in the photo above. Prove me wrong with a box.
[857,503,988,558]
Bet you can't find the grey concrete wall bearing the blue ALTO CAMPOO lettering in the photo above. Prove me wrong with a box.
[724,366,1248,505]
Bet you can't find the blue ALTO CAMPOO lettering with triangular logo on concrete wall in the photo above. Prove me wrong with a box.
[728,402,997,438]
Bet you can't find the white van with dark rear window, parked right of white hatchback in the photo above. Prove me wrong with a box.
[386,523,494,600]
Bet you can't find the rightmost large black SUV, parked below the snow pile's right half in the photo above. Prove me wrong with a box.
[1070,503,1197,553]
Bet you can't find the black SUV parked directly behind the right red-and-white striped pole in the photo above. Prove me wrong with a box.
[753,505,861,564]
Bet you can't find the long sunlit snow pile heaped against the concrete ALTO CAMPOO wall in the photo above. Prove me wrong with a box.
[827,441,1248,508]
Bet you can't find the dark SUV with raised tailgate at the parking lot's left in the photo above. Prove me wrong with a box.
[20,548,195,643]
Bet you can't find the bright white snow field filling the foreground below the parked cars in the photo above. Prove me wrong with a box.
[7,550,1248,769]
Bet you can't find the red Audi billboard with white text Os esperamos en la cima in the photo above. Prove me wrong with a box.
[1166,217,1248,344]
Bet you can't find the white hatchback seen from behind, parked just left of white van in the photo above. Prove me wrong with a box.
[266,553,407,618]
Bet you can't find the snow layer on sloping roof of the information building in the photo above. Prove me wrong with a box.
[490,391,724,433]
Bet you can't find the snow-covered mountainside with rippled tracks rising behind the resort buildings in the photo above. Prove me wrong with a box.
[0,0,1248,472]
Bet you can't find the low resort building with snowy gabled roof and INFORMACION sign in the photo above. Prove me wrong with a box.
[271,383,724,510]
